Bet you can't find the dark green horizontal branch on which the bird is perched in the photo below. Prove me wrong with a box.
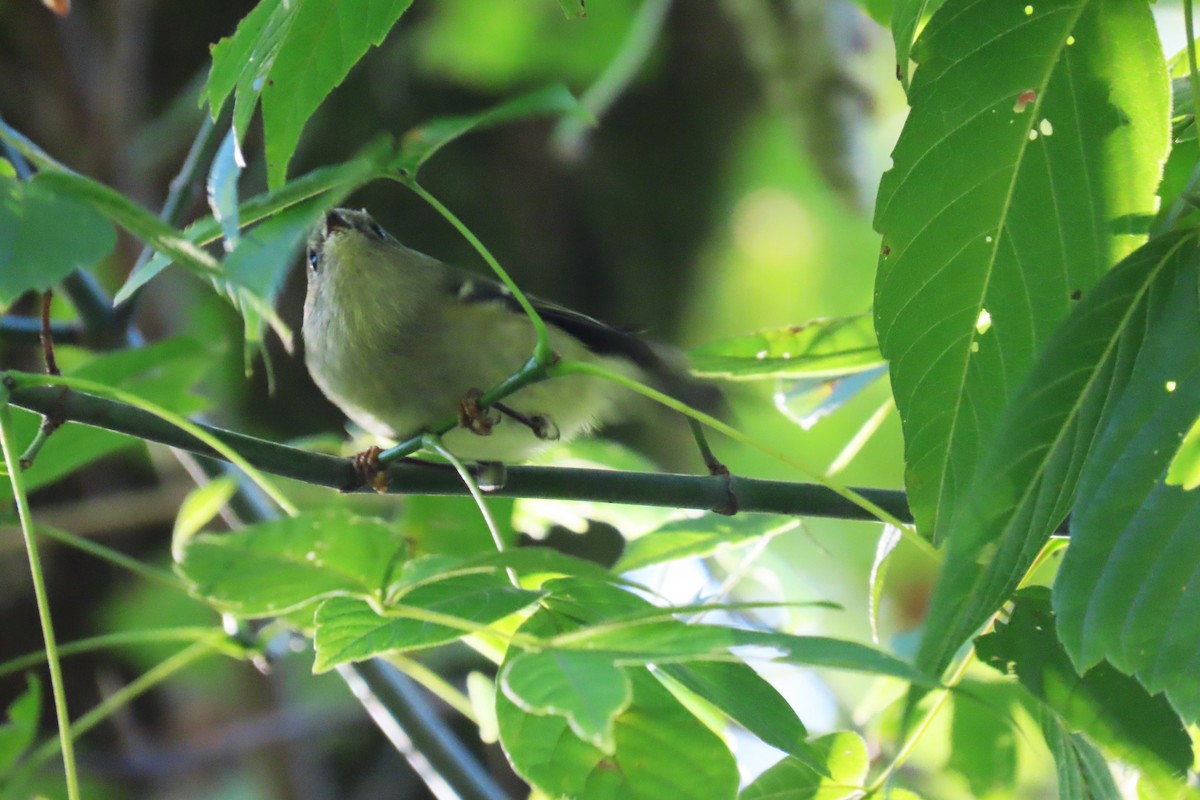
[0,372,912,521]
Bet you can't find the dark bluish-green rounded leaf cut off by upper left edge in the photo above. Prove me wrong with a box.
[0,174,116,304]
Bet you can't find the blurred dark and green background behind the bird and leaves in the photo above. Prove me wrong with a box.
[0,0,1176,799]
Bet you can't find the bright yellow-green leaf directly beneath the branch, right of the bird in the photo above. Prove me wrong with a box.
[612,513,800,572]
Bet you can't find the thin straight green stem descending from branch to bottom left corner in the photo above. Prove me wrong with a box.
[0,407,79,800]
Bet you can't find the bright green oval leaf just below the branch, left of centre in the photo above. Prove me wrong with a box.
[176,509,407,616]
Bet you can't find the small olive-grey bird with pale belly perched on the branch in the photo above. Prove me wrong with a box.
[304,209,720,464]
